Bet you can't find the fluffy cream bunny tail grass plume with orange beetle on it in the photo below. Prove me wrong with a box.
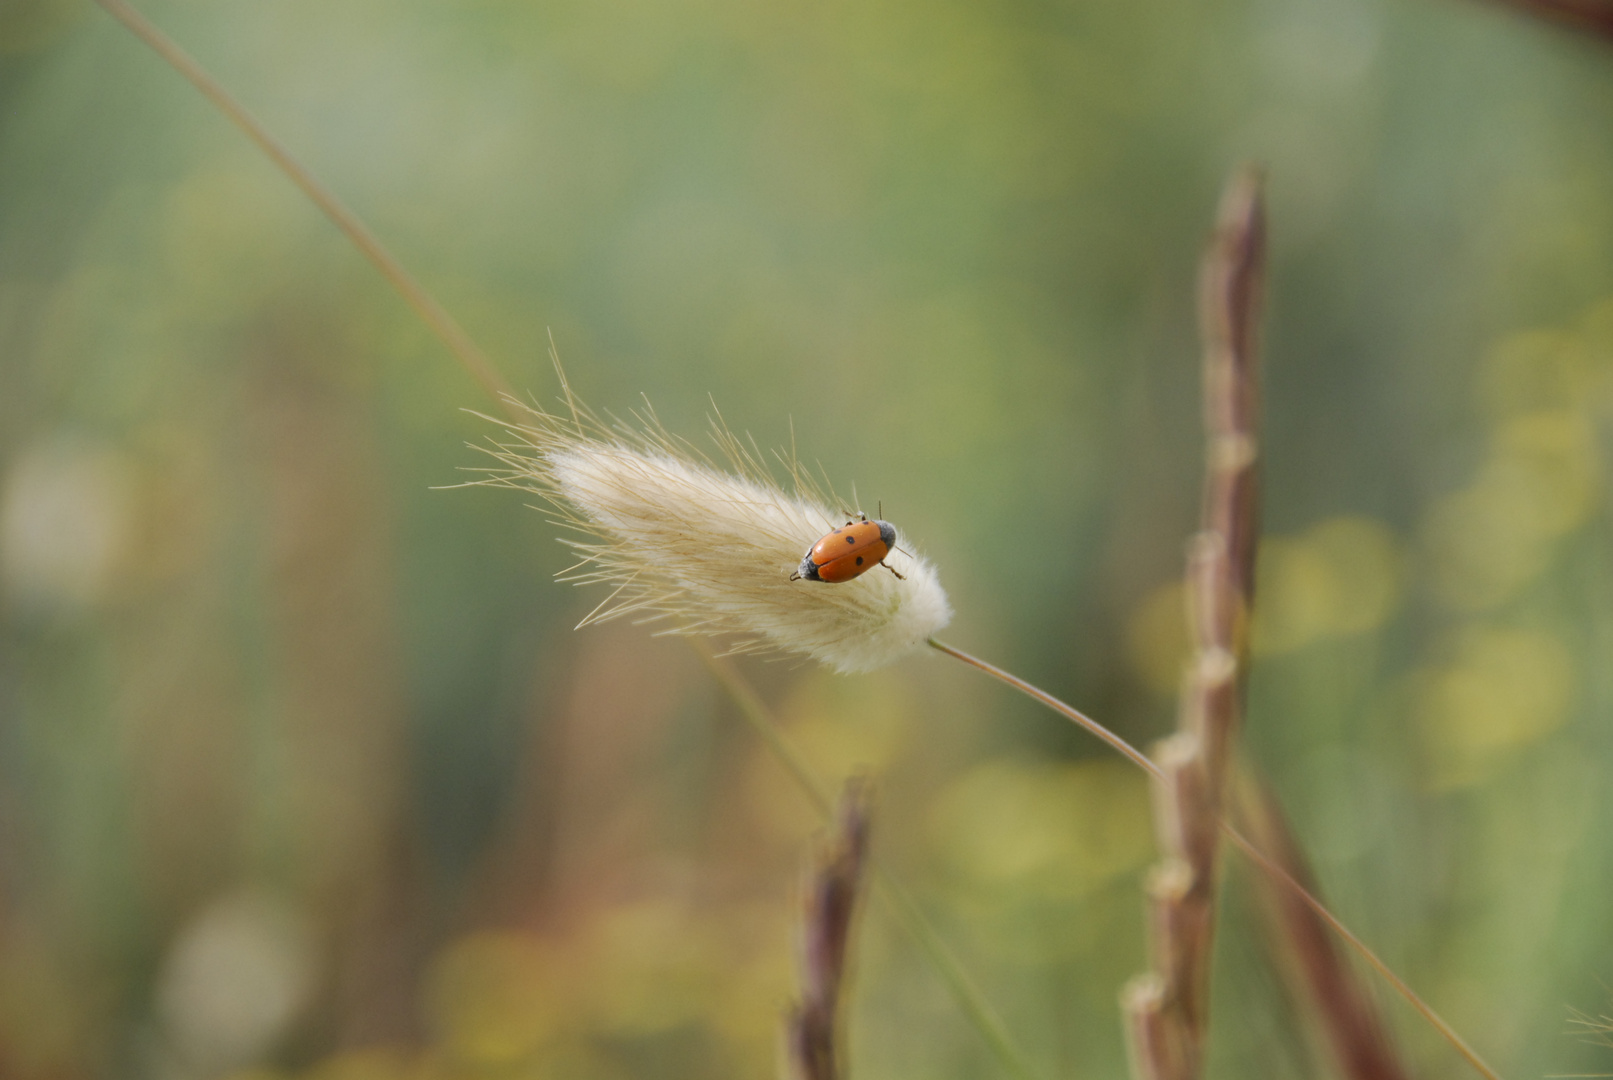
[481,379,952,674]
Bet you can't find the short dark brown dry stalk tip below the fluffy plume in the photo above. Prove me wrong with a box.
[784,779,868,1080]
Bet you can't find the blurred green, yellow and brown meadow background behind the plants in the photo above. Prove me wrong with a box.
[0,0,1613,1080]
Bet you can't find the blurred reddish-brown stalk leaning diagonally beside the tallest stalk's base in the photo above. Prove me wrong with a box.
[1237,783,1411,1080]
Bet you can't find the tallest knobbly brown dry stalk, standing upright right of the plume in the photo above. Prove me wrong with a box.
[1121,166,1266,1080]
